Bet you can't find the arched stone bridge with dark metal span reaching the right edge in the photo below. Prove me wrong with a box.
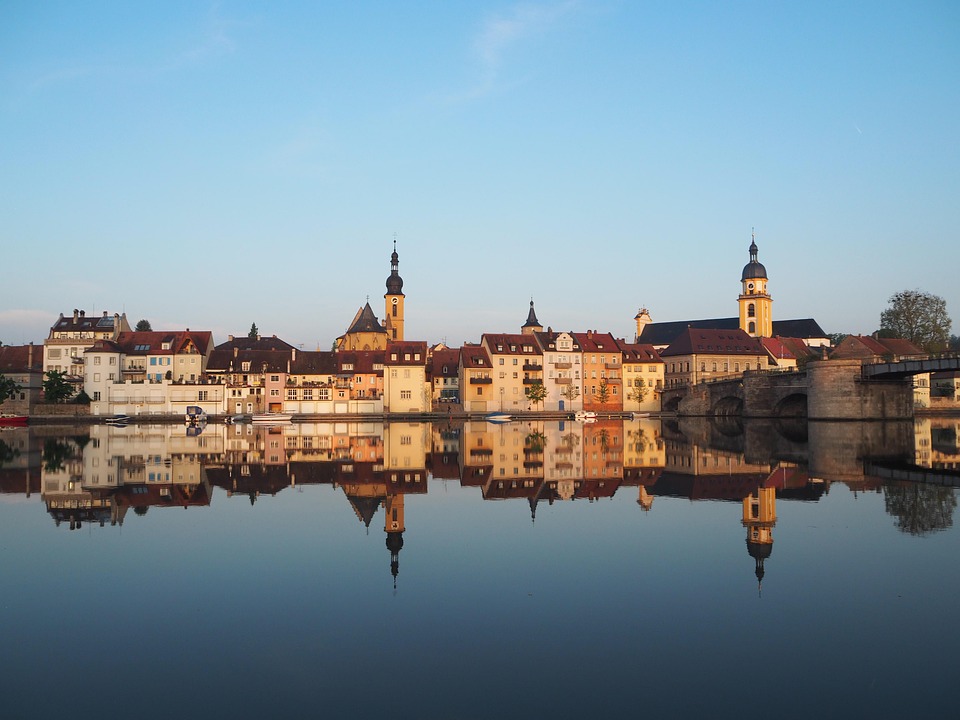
[661,354,960,420]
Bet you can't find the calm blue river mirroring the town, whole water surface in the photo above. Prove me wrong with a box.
[0,419,960,719]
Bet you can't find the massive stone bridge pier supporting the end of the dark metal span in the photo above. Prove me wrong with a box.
[807,360,913,420]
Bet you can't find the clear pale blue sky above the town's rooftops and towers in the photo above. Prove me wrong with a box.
[0,0,960,349]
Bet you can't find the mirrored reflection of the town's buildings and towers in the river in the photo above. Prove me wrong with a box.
[0,418,960,581]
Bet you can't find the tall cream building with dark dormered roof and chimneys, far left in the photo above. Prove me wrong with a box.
[43,309,131,385]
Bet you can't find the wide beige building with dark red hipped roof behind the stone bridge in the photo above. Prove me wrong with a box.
[660,328,767,387]
